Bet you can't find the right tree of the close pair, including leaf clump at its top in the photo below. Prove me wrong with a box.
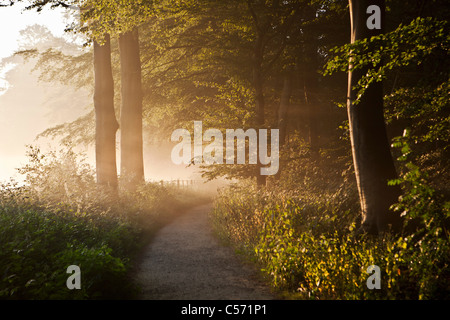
[83,0,151,189]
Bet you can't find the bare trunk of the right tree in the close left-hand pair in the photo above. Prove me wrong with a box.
[119,28,144,189]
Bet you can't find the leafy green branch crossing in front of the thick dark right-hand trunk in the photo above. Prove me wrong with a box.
[324,18,450,99]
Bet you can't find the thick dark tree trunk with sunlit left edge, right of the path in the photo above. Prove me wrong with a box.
[347,0,401,234]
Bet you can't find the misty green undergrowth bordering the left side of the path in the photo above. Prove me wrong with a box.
[0,147,204,300]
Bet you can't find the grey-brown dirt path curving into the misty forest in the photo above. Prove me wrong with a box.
[132,205,276,300]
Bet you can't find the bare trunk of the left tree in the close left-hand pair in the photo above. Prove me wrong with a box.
[94,35,119,193]
